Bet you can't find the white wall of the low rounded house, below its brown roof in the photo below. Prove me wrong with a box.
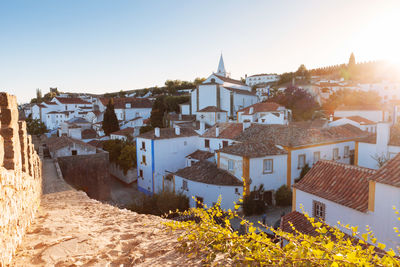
[174,175,243,210]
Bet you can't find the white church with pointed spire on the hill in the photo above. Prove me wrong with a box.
[190,55,259,117]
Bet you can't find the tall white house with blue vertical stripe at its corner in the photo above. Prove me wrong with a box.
[136,128,199,194]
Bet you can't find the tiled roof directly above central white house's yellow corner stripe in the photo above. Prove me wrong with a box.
[219,142,287,158]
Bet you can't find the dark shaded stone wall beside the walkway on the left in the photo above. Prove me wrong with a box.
[57,152,110,200]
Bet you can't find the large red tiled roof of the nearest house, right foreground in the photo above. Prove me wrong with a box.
[293,160,376,212]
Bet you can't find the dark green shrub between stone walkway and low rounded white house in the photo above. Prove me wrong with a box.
[128,191,189,216]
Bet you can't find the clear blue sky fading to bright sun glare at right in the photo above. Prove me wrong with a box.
[0,0,400,103]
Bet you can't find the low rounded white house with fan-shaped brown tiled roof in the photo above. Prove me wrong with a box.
[170,161,243,210]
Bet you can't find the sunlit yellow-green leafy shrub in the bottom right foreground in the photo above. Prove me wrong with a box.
[164,200,400,266]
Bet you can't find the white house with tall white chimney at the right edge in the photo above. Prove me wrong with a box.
[356,122,400,169]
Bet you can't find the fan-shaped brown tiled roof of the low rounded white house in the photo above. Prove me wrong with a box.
[175,161,243,186]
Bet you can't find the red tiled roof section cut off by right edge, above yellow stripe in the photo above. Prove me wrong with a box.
[370,154,400,187]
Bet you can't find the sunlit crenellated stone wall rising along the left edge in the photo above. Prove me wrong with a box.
[0,93,42,266]
